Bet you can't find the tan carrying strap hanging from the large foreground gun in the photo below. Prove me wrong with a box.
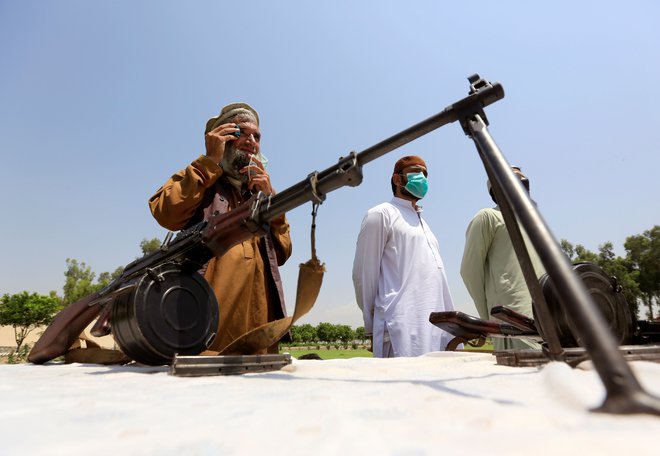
[215,203,325,355]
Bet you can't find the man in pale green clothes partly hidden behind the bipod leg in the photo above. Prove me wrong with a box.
[461,166,545,350]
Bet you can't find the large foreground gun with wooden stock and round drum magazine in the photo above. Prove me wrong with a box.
[28,75,504,365]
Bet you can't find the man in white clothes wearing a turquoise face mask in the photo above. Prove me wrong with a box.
[353,155,454,358]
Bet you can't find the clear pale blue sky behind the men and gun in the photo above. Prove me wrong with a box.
[0,0,660,327]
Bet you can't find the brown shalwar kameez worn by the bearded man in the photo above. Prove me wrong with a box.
[149,155,291,353]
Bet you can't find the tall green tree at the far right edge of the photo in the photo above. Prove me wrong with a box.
[624,225,660,319]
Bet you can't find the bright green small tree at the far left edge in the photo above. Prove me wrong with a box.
[0,291,61,352]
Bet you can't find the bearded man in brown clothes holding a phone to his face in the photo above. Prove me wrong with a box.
[149,103,291,353]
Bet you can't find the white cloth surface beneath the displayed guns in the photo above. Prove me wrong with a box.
[0,352,660,456]
